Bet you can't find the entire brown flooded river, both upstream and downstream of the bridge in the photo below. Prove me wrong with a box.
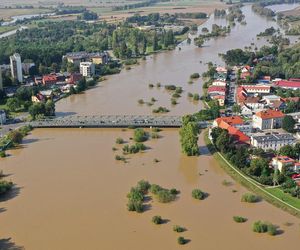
[0,3,300,250]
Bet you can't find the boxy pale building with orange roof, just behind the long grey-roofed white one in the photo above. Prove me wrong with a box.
[252,109,285,130]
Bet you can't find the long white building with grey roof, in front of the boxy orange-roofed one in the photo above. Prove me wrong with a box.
[251,133,296,150]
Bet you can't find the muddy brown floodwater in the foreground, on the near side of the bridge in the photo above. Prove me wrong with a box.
[0,129,300,250]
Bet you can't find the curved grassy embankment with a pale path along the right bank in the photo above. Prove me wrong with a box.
[204,130,300,218]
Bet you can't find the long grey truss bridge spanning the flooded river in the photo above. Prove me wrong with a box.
[30,115,208,128]
